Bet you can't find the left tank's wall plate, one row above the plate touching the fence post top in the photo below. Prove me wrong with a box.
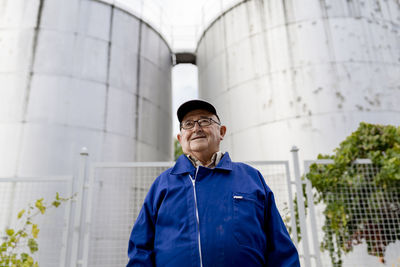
[27,75,106,130]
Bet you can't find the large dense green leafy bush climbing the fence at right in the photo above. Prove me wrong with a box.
[307,123,400,266]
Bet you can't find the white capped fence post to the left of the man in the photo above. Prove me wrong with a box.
[70,147,89,266]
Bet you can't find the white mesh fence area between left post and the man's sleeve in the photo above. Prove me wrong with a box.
[83,162,173,267]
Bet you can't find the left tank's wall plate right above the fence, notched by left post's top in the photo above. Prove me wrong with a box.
[18,123,102,176]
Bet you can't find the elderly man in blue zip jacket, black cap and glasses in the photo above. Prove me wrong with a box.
[127,100,300,267]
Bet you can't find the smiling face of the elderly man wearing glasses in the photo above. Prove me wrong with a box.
[177,109,226,157]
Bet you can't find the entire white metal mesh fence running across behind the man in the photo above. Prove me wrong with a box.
[0,149,400,267]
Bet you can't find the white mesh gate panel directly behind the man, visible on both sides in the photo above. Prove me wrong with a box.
[73,154,306,267]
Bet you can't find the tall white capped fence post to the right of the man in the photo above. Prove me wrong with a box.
[290,146,311,266]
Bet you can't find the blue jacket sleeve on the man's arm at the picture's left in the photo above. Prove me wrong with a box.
[126,181,156,267]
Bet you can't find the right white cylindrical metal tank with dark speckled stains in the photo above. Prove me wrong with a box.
[197,0,400,160]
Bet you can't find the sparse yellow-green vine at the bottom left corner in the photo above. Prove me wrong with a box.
[0,193,74,267]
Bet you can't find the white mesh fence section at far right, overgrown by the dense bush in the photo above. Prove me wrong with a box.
[306,160,400,267]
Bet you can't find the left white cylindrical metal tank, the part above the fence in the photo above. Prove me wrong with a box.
[0,0,172,177]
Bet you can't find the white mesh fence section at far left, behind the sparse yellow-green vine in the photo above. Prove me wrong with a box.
[0,176,72,267]
